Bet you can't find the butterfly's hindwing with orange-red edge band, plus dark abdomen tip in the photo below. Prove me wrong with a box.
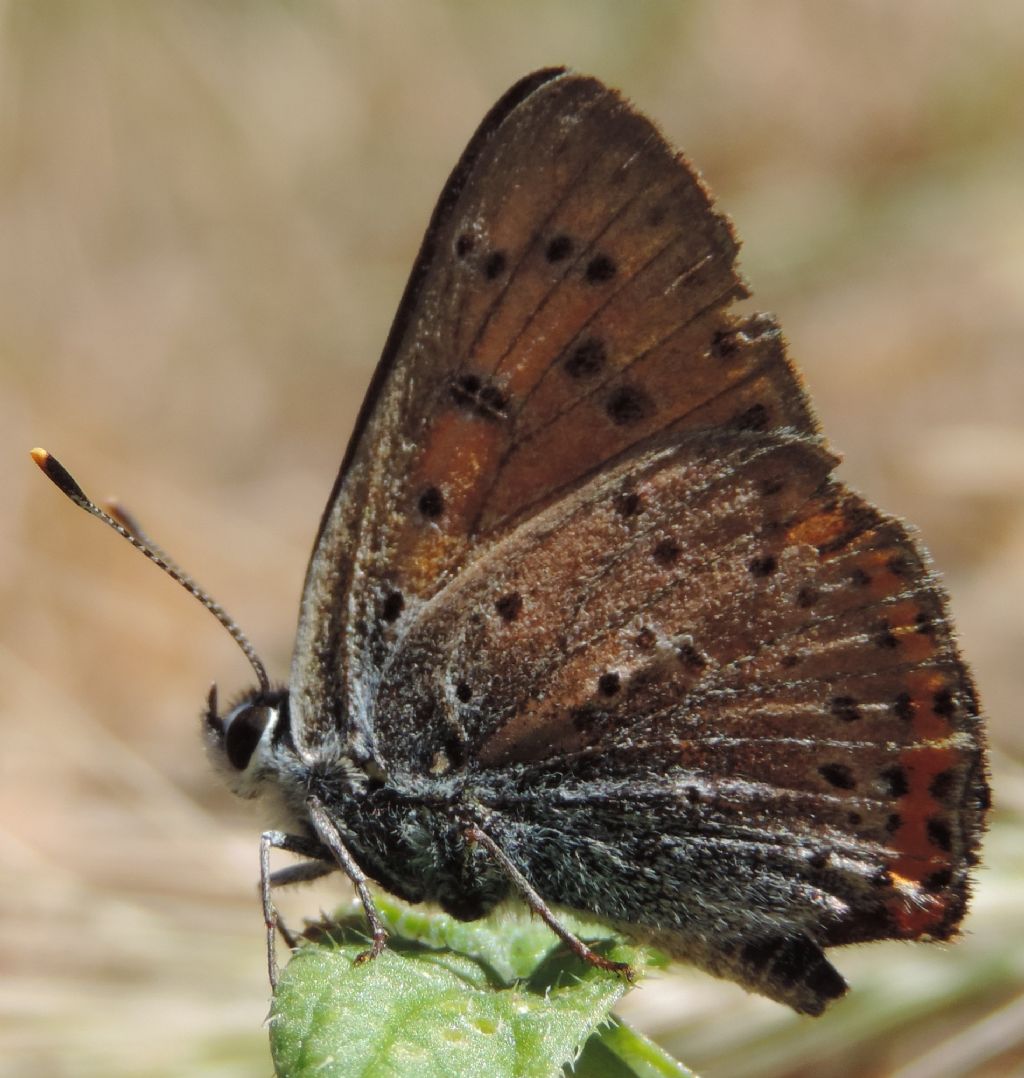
[378,430,987,1013]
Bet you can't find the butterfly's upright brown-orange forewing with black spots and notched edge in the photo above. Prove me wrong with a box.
[290,70,814,758]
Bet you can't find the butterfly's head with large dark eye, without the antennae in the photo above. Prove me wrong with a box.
[203,686,297,798]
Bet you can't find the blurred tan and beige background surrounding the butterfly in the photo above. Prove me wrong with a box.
[0,0,1024,1078]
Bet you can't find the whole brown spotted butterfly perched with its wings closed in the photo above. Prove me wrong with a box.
[34,69,988,1014]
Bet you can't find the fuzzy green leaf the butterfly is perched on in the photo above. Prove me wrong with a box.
[271,897,687,1078]
